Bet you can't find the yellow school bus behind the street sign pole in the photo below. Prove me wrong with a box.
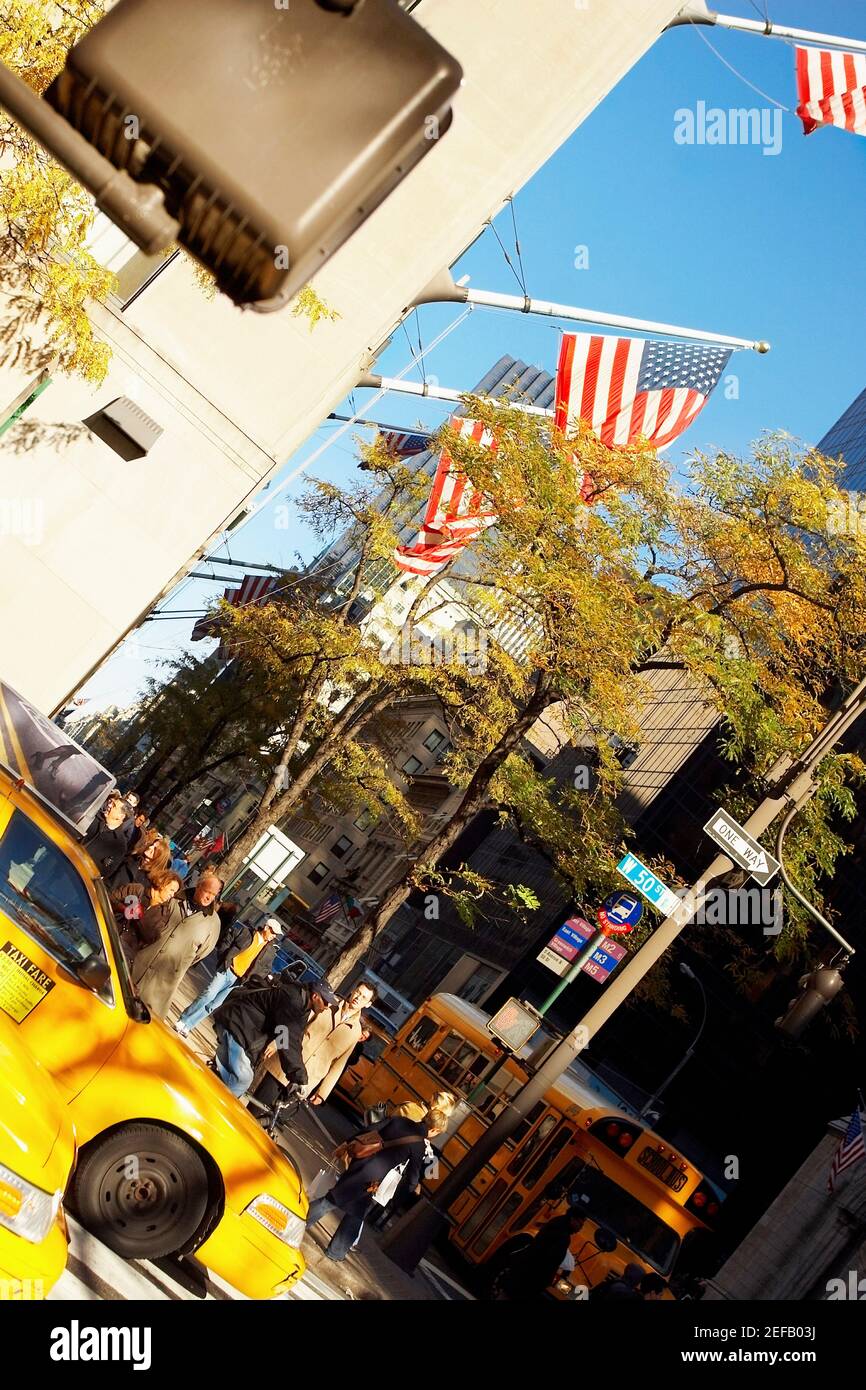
[357,994,721,1297]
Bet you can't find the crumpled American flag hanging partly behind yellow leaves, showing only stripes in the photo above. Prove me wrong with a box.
[393,416,496,574]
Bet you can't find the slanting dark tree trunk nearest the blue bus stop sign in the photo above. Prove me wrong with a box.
[328,680,559,987]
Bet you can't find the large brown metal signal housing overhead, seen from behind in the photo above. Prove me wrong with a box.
[40,0,461,309]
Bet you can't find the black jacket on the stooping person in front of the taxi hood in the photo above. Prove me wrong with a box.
[214,976,311,1086]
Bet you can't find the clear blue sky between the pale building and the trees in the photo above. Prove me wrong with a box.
[83,0,866,705]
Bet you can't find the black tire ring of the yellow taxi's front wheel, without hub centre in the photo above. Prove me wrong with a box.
[71,1125,210,1259]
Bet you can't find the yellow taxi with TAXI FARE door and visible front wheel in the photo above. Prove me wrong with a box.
[0,761,307,1298]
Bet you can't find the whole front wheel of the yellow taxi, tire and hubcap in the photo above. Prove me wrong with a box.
[71,1125,209,1259]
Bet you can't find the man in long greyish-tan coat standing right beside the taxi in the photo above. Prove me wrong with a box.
[132,870,222,1019]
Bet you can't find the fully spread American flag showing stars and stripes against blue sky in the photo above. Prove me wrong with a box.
[555,334,731,449]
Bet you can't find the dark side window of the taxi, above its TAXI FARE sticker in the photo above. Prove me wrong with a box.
[0,810,106,970]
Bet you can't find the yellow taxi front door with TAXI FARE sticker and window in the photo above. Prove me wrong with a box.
[0,792,129,1101]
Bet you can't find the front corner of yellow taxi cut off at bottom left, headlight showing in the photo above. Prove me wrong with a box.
[0,1013,75,1300]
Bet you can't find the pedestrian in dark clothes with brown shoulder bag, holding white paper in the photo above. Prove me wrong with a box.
[307,1111,448,1261]
